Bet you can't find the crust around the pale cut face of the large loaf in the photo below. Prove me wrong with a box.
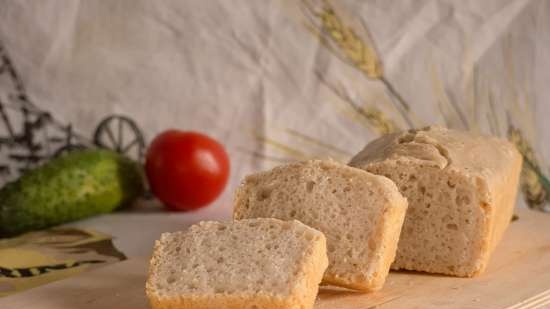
[350,127,522,277]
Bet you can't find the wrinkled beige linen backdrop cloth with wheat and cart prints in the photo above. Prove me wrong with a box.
[0,0,550,217]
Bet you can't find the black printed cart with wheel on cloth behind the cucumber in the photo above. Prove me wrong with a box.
[0,42,145,185]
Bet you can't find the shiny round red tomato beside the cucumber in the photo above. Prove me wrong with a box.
[145,130,229,210]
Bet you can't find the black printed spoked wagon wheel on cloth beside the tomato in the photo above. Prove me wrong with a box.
[94,115,145,162]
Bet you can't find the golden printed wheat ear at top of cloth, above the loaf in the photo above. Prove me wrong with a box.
[303,1,414,128]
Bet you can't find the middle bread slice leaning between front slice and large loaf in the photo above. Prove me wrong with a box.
[234,160,407,291]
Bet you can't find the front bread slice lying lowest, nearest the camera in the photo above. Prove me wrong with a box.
[146,219,328,309]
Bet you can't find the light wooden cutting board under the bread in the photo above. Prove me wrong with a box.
[0,209,550,309]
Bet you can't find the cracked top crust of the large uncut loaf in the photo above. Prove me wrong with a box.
[350,126,518,181]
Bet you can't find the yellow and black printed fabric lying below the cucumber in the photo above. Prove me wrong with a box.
[0,228,125,297]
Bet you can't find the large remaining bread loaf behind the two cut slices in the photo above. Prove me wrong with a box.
[350,127,522,276]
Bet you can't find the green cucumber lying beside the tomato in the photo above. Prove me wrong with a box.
[0,149,144,237]
